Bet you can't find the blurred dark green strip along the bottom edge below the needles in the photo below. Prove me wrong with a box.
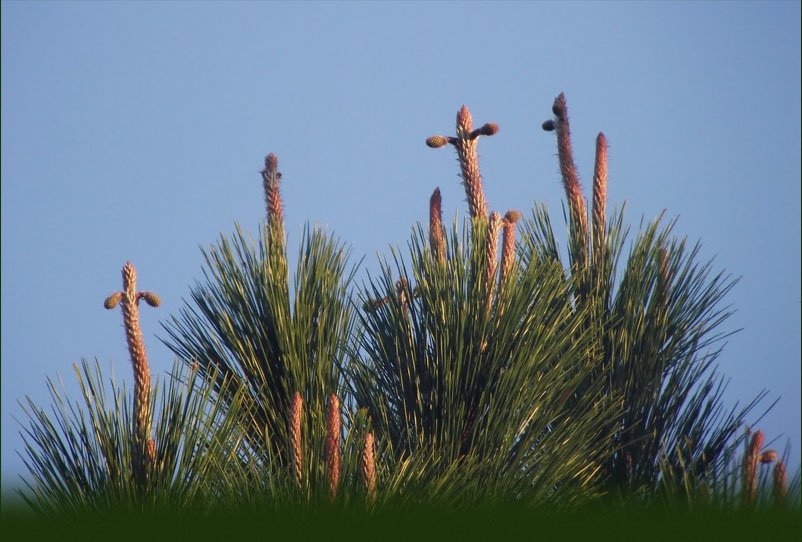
[0,506,802,542]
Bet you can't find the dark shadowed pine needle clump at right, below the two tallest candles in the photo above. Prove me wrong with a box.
[521,208,765,502]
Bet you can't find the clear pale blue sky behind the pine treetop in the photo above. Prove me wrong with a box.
[2,1,802,488]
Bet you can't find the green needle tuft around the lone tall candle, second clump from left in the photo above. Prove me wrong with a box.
[159,226,359,504]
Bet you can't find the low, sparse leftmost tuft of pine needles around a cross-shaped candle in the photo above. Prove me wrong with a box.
[15,361,239,515]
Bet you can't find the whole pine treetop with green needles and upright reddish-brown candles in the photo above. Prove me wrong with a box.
[3,94,800,536]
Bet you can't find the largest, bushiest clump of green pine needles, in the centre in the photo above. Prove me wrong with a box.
[351,220,620,504]
